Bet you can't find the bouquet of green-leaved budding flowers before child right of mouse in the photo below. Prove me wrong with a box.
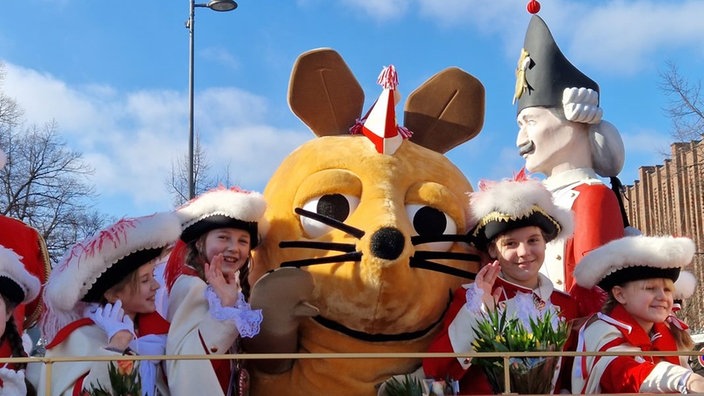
[472,293,569,394]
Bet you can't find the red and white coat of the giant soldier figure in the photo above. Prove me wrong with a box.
[540,168,624,316]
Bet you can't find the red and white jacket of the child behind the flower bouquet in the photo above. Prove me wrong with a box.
[423,274,577,394]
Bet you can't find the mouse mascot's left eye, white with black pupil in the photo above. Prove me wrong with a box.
[301,194,359,238]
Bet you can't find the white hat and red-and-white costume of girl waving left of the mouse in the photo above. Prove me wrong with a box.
[164,186,266,396]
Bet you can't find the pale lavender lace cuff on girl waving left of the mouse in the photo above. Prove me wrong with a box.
[205,286,263,338]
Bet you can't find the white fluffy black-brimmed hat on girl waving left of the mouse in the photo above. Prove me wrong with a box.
[176,186,269,247]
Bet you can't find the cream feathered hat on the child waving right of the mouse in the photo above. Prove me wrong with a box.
[469,170,573,250]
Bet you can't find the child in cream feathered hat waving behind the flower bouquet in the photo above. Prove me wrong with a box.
[423,171,576,394]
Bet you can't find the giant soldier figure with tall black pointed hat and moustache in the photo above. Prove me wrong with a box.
[514,2,626,316]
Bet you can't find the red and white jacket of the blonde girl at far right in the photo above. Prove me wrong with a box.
[572,305,692,393]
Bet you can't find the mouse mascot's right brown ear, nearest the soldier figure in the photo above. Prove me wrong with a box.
[403,67,484,154]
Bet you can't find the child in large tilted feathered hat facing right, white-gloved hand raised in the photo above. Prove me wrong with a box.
[29,212,180,396]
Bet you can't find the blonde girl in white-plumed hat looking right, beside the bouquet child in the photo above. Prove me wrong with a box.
[572,236,704,393]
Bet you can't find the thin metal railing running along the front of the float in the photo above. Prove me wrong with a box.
[0,351,703,396]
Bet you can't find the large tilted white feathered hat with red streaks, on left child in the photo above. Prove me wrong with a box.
[44,212,181,311]
